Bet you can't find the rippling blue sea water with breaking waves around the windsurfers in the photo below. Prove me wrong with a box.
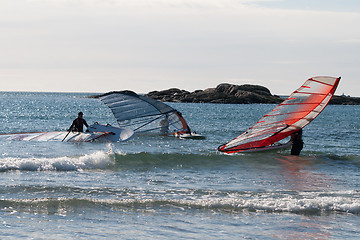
[0,92,360,239]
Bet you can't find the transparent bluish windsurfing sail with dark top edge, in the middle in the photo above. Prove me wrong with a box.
[95,90,190,135]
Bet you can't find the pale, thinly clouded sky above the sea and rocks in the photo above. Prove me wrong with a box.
[0,0,360,97]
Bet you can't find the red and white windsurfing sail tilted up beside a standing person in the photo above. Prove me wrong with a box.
[218,77,340,153]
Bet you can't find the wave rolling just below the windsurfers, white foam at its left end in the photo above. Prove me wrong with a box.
[0,148,360,172]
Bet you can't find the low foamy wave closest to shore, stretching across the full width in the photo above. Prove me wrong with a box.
[0,190,360,215]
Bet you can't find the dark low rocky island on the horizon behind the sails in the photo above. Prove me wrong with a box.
[146,83,360,105]
